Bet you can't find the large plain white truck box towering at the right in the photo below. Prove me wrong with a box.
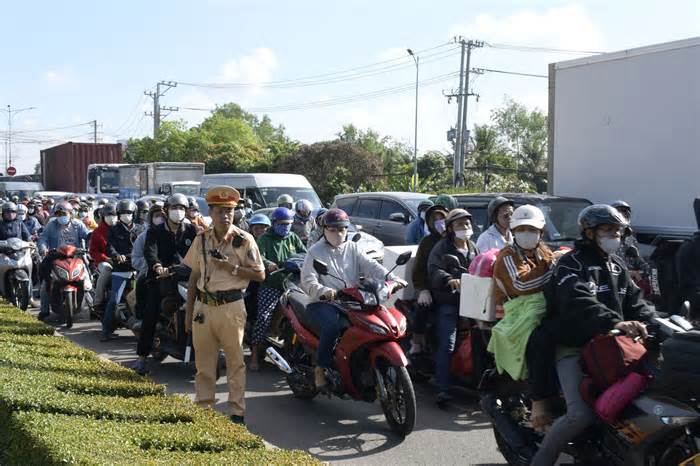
[548,37,700,241]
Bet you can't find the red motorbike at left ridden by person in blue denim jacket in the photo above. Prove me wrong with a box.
[49,245,88,328]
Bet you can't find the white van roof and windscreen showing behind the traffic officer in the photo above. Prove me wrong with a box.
[201,173,321,210]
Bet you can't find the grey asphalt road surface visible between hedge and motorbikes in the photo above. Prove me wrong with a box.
[50,316,506,465]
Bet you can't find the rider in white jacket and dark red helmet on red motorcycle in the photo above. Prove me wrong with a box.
[301,209,405,388]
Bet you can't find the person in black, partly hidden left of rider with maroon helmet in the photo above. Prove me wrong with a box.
[409,205,449,354]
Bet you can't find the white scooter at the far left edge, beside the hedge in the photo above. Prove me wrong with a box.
[0,238,35,311]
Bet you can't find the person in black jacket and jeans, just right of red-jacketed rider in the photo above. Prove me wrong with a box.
[100,199,136,342]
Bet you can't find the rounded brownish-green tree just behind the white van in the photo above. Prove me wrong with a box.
[276,141,383,202]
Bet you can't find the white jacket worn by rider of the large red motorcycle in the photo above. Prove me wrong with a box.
[301,238,395,301]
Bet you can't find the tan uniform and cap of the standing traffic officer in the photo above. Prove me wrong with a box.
[184,186,264,416]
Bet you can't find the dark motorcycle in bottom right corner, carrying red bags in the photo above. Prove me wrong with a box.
[481,316,700,466]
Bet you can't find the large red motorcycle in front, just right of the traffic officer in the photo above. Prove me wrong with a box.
[267,251,416,437]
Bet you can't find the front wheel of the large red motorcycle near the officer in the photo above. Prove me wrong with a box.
[379,364,416,438]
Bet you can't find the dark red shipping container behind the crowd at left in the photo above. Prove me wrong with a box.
[41,142,123,193]
